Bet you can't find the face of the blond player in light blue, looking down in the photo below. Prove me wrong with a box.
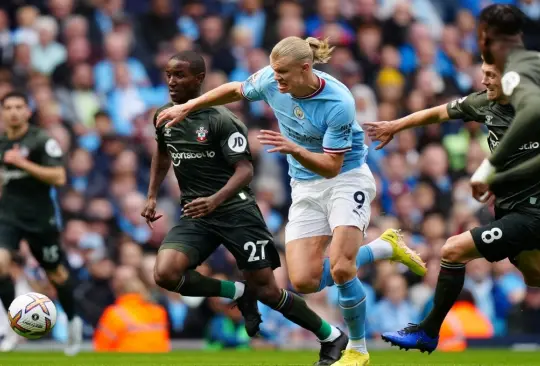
[270,57,309,94]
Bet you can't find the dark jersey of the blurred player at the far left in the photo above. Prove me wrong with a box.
[0,126,63,232]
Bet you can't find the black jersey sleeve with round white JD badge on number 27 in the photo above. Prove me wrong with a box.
[211,107,252,165]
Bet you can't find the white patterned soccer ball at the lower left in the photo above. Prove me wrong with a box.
[8,292,56,339]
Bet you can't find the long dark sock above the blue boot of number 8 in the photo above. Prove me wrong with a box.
[420,260,465,337]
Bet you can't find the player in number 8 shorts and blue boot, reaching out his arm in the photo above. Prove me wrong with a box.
[372,70,540,353]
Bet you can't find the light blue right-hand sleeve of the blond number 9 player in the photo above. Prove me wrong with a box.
[323,98,356,154]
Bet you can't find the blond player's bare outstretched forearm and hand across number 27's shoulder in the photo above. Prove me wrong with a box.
[157,82,243,127]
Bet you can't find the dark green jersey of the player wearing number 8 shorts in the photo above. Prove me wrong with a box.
[447,91,540,209]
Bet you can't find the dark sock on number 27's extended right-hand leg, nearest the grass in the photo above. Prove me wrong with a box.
[267,289,332,340]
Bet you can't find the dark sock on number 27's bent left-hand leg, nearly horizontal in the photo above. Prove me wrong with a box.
[174,270,240,299]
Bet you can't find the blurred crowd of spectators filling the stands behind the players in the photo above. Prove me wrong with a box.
[0,0,540,348]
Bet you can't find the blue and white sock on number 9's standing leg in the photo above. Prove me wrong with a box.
[336,277,367,353]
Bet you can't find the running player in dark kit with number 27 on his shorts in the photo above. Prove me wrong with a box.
[142,51,348,365]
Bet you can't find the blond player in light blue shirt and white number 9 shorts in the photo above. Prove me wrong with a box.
[157,37,425,366]
